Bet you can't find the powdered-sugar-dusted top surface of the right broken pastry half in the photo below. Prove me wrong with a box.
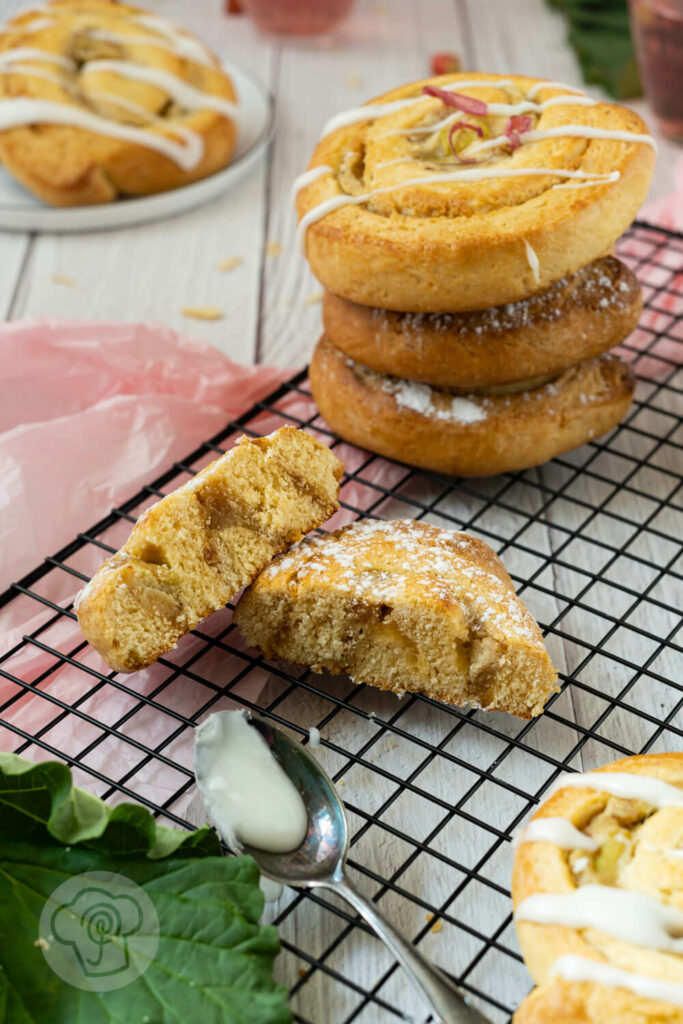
[262,519,540,642]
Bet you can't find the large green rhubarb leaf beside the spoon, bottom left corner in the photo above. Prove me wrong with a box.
[0,755,292,1024]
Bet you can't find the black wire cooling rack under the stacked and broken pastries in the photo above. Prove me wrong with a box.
[0,223,683,1024]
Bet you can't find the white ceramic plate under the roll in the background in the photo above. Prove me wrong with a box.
[0,60,274,232]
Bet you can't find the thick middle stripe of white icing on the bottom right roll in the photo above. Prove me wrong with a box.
[515,885,683,953]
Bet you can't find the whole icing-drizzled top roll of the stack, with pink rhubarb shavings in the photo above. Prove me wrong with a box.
[296,73,654,313]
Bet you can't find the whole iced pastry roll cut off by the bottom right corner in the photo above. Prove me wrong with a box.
[512,754,683,1024]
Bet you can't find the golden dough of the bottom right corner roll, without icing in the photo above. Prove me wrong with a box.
[512,754,683,1024]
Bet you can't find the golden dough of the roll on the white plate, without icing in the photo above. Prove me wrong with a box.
[0,0,237,206]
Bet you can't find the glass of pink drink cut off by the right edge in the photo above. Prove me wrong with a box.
[631,0,683,141]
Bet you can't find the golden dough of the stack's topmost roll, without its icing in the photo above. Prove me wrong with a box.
[297,73,654,312]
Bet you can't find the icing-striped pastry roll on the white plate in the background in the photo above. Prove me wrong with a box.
[0,0,243,206]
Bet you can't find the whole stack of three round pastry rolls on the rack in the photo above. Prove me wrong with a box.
[296,74,654,476]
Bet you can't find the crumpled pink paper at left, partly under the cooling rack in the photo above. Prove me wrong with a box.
[0,319,289,799]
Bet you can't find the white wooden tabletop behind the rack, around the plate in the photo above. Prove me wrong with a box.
[0,0,680,367]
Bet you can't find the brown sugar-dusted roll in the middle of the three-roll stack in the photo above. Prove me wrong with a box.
[323,256,642,390]
